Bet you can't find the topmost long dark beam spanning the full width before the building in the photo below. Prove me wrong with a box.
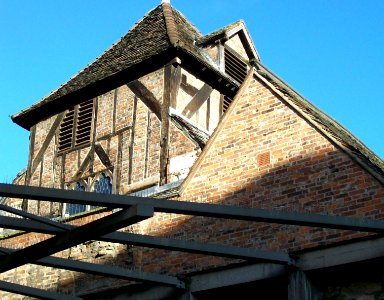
[0,184,384,233]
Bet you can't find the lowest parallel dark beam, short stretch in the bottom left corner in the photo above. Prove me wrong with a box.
[0,281,82,300]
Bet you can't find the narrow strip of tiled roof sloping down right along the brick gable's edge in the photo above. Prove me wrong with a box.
[255,62,384,184]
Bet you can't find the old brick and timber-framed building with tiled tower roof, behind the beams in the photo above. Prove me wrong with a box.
[0,3,384,299]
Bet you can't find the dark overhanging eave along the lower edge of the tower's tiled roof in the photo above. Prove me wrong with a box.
[12,46,238,130]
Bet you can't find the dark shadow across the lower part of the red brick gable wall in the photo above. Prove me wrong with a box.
[3,152,384,297]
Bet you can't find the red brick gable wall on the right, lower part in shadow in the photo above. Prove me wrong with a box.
[130,72,384,272]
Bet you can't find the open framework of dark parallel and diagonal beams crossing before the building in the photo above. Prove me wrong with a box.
[0,184,384,299]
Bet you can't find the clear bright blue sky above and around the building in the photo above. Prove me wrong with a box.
[0,0,384,182]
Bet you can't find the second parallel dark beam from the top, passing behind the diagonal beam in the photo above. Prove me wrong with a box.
[0,217,294,265]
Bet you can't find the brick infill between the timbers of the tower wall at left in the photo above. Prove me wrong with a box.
[0,64,225,299]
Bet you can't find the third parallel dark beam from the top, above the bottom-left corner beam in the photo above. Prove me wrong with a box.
[0,248,185,289]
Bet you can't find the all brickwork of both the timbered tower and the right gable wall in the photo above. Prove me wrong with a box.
[0,66,384,297]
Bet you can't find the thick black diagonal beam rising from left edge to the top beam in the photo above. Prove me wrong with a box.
[0,204,153,273]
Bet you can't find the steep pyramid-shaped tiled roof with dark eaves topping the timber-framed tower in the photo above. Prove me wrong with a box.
[12,3,237,129]
